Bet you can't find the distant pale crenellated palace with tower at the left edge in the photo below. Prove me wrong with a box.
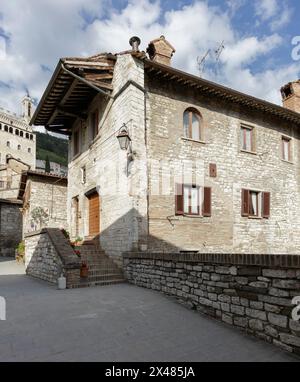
[0,95,36,199]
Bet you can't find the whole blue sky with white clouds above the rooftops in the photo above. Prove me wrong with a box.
[0,0,300,112]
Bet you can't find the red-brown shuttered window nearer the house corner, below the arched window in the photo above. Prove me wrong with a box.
[175,184,211,217]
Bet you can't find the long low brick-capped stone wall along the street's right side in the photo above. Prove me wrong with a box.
[124,253,300,355]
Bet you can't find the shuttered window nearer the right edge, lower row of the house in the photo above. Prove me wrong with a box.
[242,189,270,219]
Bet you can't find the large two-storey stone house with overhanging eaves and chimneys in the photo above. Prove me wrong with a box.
[31,36,300,261]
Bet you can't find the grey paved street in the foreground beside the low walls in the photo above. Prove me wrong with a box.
[0,260,296,362]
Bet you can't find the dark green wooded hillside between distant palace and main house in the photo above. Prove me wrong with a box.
[36,132,68,166]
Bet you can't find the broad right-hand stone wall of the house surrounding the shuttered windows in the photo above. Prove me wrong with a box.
[146,76,300,254]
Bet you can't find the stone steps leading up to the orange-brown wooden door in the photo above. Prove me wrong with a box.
[73,238,125,288]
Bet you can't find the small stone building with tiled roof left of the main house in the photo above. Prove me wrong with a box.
[18,170,68,237]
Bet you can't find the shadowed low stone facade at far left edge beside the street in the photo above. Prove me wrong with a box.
[0,199,22,256]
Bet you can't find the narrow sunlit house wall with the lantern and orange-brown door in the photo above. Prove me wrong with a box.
[67,54,147,260]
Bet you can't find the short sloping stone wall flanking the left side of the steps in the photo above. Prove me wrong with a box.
[25,228,80,288]
